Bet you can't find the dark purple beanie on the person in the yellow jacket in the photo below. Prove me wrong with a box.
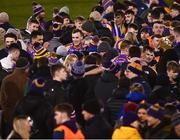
[123,111,138,126]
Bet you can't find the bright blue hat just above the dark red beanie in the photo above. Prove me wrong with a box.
[126,92,146,104]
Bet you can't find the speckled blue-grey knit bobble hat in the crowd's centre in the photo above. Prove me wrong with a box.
[71,60,85,77]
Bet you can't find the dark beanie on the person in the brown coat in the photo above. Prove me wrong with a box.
[16,57,29,69]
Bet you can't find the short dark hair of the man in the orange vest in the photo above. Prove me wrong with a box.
[54,103,73,118]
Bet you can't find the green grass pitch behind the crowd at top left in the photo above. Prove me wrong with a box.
[0,0,97,28]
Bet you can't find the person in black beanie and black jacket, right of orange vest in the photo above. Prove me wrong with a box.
[82,99,112,139]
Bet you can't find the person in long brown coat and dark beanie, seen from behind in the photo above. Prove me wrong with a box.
[0,58,29,138]
